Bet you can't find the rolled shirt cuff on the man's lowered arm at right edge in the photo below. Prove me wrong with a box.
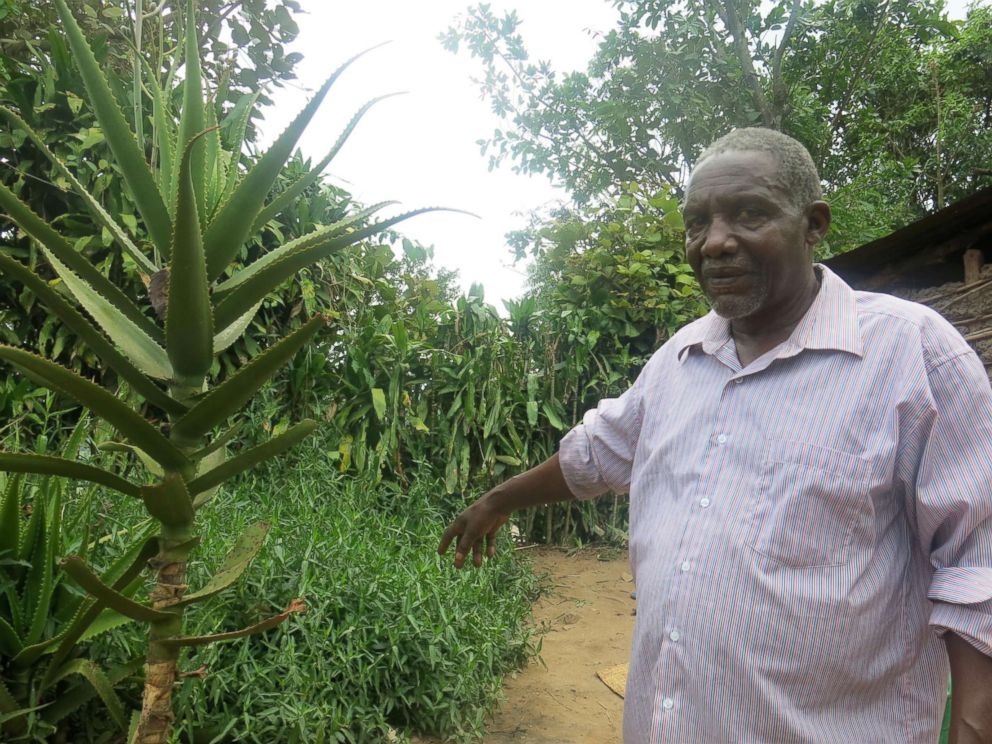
[927,566,992,656]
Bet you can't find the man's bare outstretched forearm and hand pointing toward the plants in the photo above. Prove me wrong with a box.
[437,454,575,568]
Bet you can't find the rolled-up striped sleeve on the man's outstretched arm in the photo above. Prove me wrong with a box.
[558,362,652,499]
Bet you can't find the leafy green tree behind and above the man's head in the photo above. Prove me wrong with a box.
[443,0,992,250]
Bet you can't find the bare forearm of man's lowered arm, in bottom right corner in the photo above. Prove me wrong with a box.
[944,632,992,744]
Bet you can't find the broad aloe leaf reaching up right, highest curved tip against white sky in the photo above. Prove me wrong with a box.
[203,44,390,282]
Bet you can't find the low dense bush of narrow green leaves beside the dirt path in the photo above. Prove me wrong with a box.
[89,442,539,742]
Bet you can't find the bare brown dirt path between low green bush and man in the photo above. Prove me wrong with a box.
[414,548,634,744]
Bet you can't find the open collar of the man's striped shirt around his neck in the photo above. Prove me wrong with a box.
[677,264,863,361]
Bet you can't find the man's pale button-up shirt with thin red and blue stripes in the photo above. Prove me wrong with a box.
[560,266,992,744]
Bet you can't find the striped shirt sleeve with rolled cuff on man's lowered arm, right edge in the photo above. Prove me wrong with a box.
[916,350,992,656]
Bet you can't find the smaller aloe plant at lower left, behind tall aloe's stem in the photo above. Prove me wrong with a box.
[0,417,156,738]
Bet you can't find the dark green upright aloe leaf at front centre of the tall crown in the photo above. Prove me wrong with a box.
[165,130,214,381]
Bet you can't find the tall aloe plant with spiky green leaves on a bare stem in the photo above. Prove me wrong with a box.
[0,0,442,744]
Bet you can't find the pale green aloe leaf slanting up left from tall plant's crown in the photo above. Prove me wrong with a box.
[41,246,175,380]
